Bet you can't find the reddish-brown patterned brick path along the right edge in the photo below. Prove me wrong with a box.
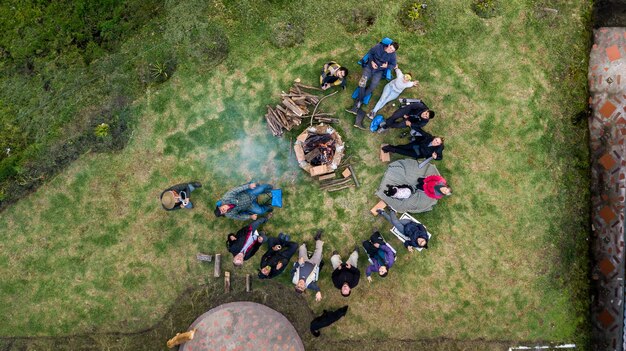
[589,27,626,350]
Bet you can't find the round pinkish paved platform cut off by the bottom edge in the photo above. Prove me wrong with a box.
[180,302,304,351]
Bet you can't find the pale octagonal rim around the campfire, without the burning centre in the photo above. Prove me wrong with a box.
[293,123,345,177]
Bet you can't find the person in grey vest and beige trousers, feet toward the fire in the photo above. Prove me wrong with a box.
[291,230,324,301]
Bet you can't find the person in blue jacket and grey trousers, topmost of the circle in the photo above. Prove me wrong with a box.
[346,40,400,117]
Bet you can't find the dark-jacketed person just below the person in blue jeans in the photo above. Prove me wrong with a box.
[226,217,271,266]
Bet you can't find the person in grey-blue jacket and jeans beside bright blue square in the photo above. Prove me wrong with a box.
[214,183,273,221]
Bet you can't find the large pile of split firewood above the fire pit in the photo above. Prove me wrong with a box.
[265,82,339,136]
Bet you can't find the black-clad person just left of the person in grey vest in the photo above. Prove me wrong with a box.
[259,233,298,279]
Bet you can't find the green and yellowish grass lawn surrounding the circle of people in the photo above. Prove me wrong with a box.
[0,0,590,343]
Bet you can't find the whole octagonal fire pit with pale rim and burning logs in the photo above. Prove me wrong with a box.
[293,124,345,177]
